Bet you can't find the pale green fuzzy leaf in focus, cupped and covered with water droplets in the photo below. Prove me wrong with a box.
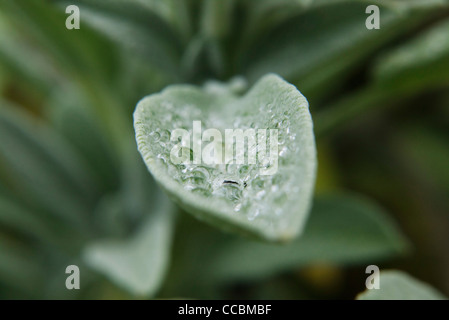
[134,75,316,241]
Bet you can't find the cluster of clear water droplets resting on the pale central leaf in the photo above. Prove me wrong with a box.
[146,100,300,220]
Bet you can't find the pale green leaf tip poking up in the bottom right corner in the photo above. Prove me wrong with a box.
[357,270,447,300]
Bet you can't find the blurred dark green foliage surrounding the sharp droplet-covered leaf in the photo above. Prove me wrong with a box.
[0,0,449,299]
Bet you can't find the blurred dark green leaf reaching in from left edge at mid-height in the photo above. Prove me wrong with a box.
[0,103,97,232]
